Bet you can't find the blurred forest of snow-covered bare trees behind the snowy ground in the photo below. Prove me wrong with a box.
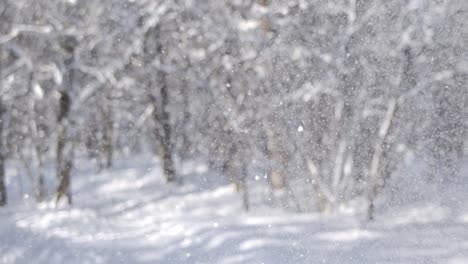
[0,0,468,219]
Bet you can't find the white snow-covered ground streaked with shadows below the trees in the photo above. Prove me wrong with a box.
[0,156,468,264]
